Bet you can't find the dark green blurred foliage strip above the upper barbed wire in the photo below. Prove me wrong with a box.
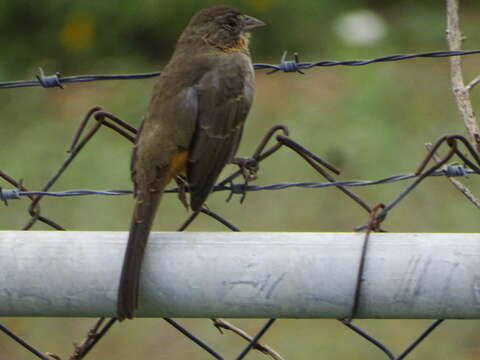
[0,0,473,78]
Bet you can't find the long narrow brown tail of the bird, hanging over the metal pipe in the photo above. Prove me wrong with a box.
[117,189,163,321]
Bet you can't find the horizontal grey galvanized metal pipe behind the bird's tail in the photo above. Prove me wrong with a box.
[0,231,480,319]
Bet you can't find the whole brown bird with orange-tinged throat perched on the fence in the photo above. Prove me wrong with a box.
[117,6,265,320]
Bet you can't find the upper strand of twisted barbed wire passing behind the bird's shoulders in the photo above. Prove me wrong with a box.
[0,50,480,89]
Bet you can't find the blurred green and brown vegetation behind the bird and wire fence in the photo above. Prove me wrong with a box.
[0,0,480,360]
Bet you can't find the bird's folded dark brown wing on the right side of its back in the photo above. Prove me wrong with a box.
[187,58,253,211]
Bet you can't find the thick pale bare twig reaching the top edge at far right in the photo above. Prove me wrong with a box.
[447,0,480,152]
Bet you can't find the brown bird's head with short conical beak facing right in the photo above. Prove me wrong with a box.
[181,6,265,51]
